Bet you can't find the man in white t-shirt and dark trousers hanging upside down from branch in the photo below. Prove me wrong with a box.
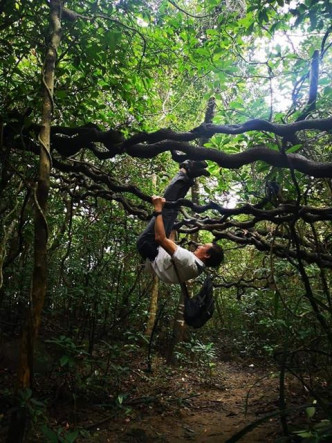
[137,160,224,284]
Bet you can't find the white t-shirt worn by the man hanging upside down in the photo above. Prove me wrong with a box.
[146,246,204,284]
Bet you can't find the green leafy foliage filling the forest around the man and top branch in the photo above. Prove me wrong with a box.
[0,0,332,441]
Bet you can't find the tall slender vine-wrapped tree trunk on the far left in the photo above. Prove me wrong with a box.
[7,0,62,442]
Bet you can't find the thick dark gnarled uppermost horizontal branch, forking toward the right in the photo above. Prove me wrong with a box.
[4,113,332,178]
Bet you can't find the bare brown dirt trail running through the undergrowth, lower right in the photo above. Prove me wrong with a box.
[85,363,286,443]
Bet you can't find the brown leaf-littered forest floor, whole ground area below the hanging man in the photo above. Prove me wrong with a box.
[0,346,308,443]
